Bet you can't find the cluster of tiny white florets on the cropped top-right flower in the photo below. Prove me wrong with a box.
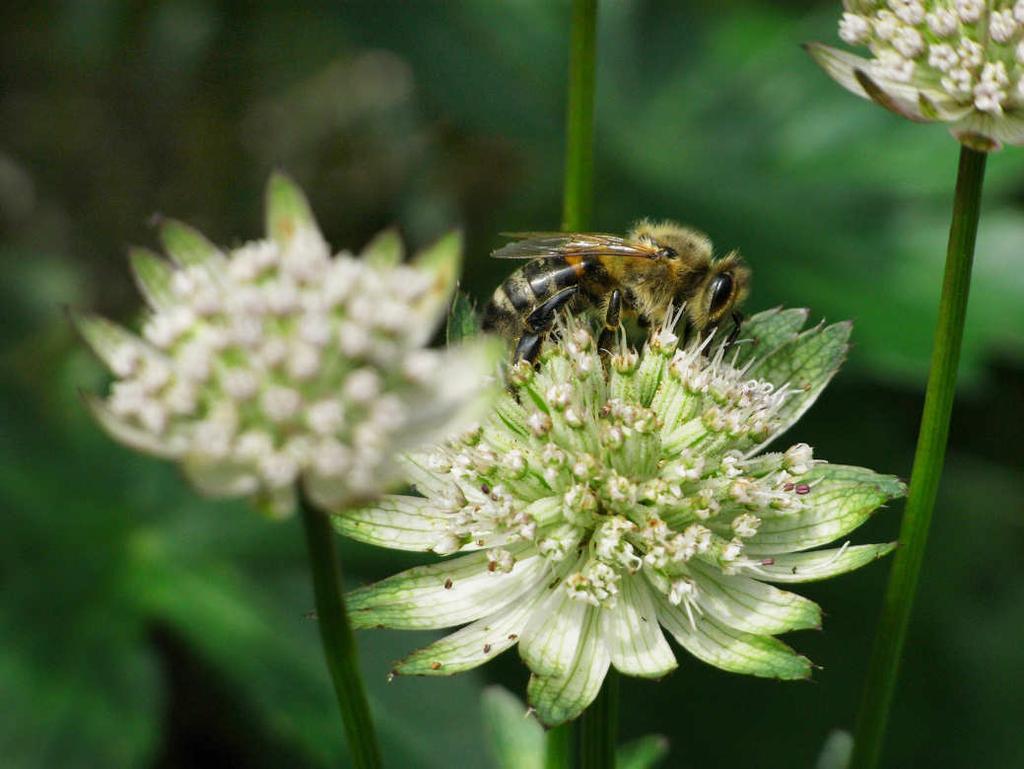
[839,0,1024,116]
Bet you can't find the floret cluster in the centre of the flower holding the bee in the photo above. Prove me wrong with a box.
[415,321,814,622]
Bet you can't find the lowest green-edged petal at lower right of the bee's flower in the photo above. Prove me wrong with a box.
[657,598,811,679]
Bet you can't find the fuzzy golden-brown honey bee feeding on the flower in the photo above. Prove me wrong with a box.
[483,220,751,362]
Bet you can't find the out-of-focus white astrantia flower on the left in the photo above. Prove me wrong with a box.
[74,174,500,515]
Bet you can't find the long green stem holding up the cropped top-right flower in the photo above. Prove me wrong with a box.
[850,146,987,769]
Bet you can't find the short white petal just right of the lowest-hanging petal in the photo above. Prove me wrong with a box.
[601,574,678,678]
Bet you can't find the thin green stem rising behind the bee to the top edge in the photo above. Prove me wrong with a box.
[562,0,597,231]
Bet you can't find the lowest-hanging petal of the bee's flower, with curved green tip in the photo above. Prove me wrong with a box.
[526,606,611,726]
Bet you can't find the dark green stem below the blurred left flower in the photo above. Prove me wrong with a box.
[300,495,381,769]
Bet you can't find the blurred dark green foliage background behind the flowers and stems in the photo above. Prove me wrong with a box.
[0,0,1024,769]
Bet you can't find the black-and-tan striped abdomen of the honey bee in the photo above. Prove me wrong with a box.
[483,255,604,339]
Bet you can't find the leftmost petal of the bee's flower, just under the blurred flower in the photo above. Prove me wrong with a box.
[331,495,451,551]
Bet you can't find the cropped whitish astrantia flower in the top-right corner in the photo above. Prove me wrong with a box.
[808,0,1024,152]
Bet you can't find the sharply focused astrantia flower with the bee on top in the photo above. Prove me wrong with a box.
[335,310,904,725]
